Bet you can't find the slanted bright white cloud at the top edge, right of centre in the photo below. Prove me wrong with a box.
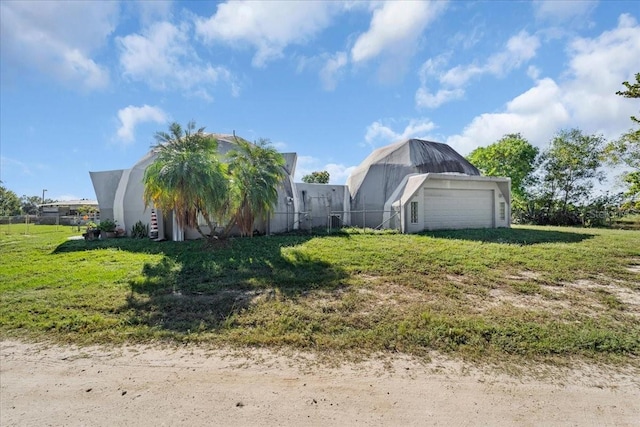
[351,0,446,63]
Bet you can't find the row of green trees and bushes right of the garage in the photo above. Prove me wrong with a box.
[467,73,640,226]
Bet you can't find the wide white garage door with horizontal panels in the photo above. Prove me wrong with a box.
[424,188,494,230]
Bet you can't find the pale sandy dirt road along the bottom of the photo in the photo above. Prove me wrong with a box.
[0,340,640,426]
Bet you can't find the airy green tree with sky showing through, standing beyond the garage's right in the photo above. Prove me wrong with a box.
[539,129,605,223]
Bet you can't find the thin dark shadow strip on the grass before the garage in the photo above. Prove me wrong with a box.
[421,228,593,246]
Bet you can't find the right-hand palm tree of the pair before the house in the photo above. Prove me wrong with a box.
[226,135,285,236]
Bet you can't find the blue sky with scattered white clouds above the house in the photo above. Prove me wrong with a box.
[0,0,640,200]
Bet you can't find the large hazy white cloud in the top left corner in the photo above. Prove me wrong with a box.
[0,1,119,90]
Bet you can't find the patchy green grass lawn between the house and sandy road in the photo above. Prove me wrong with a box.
[0,224,640,365]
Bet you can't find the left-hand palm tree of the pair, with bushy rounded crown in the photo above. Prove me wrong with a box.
[143,122,228,237]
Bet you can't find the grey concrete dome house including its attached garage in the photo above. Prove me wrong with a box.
[90,134,511,240]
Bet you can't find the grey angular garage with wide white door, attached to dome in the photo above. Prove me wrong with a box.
[385,173,511,233]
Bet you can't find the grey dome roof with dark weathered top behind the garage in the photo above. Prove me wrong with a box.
[347,139,480,226]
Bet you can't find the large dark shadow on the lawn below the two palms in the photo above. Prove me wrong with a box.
[54,235,346,334]
